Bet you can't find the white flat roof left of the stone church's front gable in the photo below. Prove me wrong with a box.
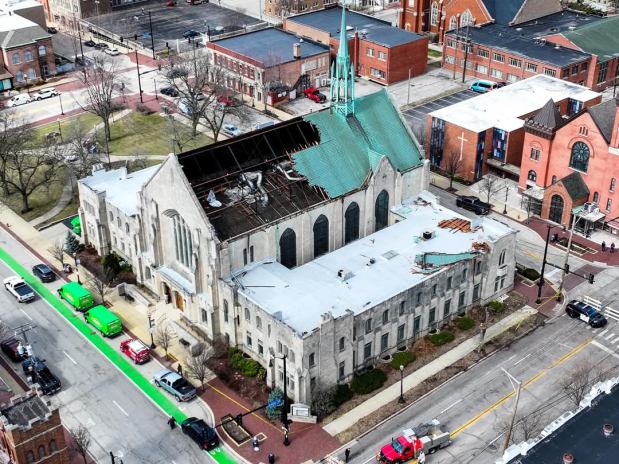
[80,165,159,216]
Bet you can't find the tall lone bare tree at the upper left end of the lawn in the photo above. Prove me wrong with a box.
[80,54,121,148]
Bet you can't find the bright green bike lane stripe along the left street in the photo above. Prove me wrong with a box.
[0,248,238,464]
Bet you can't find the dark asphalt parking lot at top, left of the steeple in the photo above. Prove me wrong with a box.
[88,1,260,51]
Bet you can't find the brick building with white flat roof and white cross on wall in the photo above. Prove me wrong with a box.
[426,74,601,181]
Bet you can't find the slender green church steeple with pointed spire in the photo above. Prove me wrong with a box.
[331,0,355,117]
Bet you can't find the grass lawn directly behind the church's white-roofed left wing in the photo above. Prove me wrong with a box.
[102,112,213,156]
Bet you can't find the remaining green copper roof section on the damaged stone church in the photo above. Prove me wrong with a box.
[293,89,423,198]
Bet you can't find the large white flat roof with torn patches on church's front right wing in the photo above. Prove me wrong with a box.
[229,192,513,334]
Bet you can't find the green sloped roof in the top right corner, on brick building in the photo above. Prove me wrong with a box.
[563,16,619,62]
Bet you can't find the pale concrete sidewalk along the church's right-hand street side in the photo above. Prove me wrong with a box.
[324,306,537,436]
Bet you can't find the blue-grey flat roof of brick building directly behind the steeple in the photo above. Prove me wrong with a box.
[286,6,422,48]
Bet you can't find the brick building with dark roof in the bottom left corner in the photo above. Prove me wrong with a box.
[0,393,70,464]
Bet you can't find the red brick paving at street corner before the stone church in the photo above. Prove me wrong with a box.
[200,379,341,464]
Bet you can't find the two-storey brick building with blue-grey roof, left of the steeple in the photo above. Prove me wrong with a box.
[207,28,329,105]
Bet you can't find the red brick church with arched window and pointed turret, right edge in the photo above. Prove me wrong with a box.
[519,95,619,234]
